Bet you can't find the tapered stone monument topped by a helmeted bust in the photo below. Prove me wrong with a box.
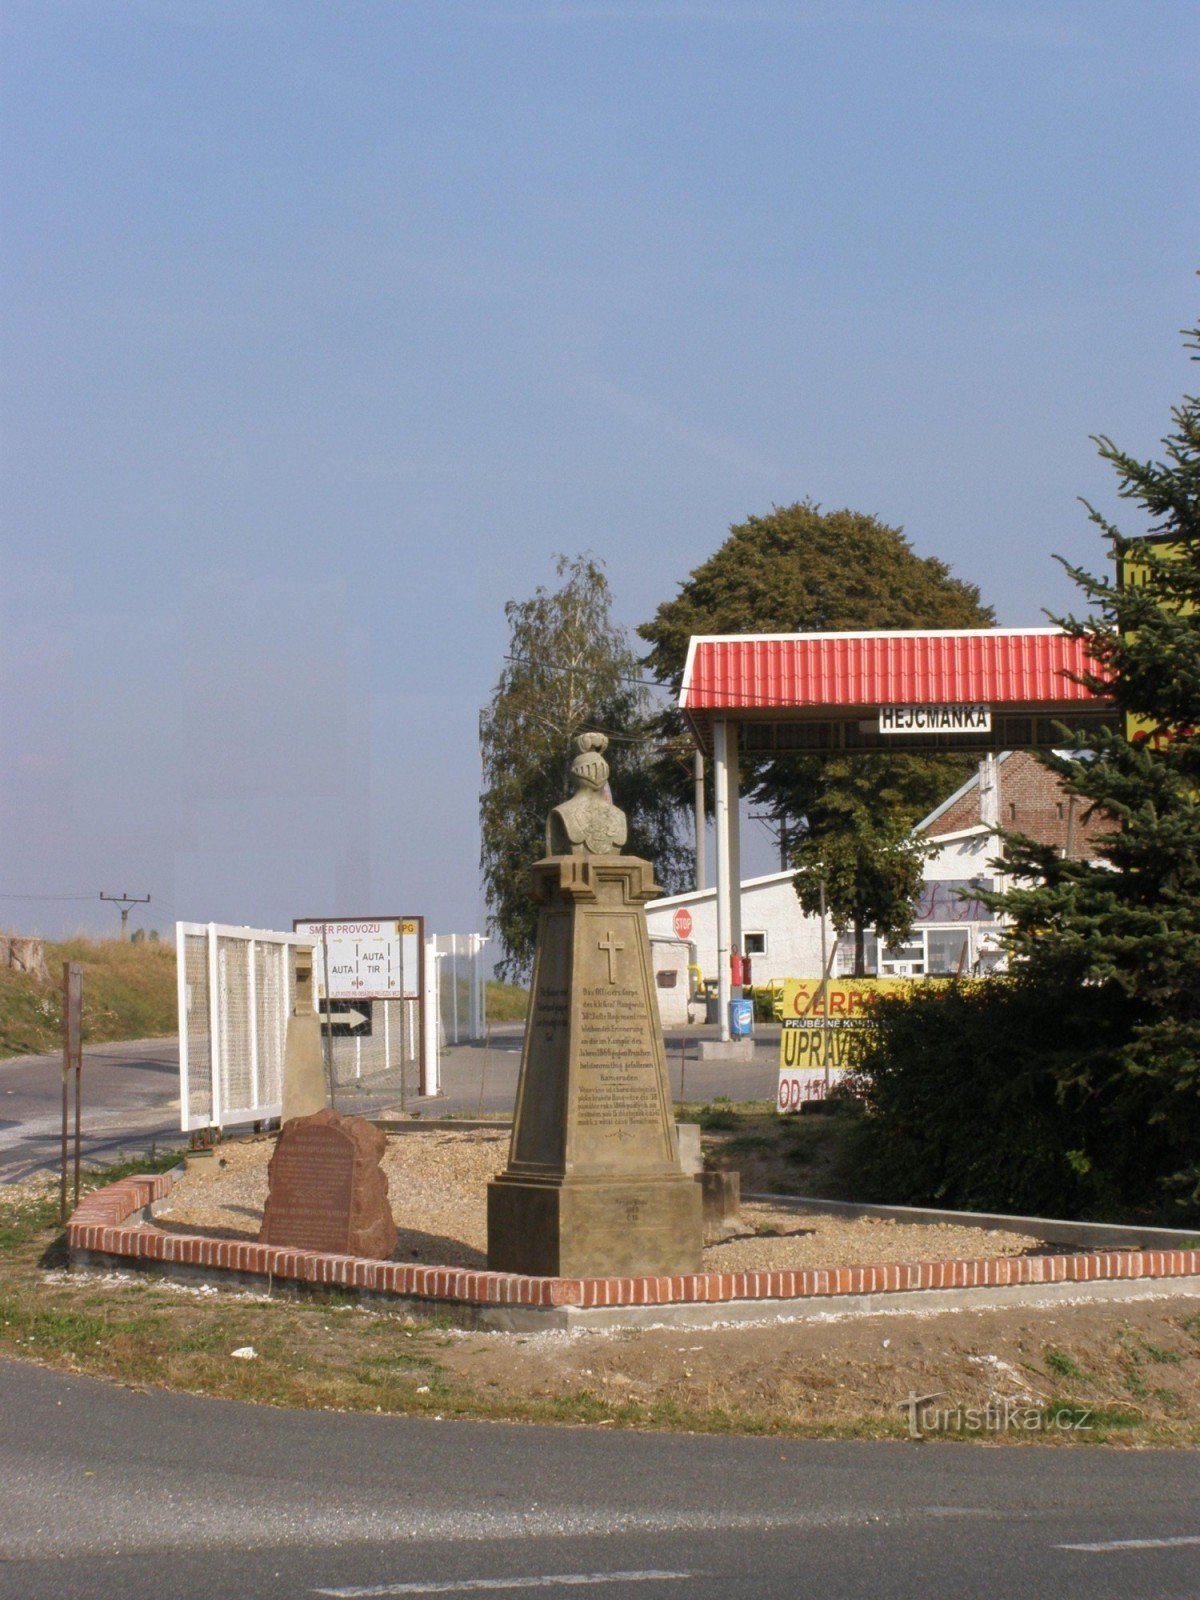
[488,733,702,1277]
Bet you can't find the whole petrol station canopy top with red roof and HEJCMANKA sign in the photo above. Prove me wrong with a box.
[680,627,1118,755]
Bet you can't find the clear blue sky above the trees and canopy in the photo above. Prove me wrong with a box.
[0,0,1200,933]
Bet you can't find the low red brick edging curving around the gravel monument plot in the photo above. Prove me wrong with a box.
[67,1173,1200,1309]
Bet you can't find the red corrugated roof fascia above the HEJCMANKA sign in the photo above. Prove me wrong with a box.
[680,627,1113,712]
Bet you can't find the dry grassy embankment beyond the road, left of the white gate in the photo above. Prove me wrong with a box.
[0,939,178,1056]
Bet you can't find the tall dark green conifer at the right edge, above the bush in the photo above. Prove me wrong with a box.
[997,330,1200,1203]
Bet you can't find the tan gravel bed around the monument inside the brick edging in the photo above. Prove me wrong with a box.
[157,1128,1040,1272]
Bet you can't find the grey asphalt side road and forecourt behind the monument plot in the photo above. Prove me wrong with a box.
[0,1022,778,1182]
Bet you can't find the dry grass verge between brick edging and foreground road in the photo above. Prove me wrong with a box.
[0,1174,1200,1445]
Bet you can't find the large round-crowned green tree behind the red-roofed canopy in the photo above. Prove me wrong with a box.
[638,501,995,970]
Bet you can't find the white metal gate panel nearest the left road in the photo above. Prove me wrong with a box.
[174,922,312,1133]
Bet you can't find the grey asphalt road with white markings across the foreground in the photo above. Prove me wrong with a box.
[0,1362,1200,1600]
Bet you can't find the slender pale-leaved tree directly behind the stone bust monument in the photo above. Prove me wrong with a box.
[480,555,691,979]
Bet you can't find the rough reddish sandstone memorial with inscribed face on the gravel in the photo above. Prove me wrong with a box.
[258,1110,395,1261]
